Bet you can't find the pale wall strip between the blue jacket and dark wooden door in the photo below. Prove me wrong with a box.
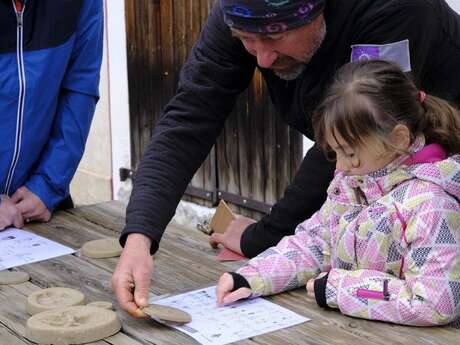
[70,0,131,205]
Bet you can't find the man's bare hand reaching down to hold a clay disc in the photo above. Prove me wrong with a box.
[112,233,153,317]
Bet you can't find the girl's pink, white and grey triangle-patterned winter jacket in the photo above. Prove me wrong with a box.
[237,138,460,326]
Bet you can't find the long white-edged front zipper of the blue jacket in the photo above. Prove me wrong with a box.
[4,0,26,195]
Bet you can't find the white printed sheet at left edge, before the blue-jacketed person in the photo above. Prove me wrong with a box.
[0,228,75,271]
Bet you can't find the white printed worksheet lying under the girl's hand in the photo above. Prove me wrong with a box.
[151,286,310,345]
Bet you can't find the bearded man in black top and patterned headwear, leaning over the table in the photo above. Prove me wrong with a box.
[112,0,460,315]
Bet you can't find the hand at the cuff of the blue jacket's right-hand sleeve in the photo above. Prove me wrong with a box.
[11,187,51,222]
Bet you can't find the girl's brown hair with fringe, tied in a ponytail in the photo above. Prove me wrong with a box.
[313,60,460,155]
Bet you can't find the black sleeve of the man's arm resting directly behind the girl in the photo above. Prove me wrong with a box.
[241,141,335,258]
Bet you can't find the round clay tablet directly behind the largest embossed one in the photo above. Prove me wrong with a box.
[26,287,85,315]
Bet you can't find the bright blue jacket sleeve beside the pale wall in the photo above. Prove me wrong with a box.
[25,0,103,211]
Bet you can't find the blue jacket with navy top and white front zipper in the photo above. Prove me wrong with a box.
[0,0,103,211]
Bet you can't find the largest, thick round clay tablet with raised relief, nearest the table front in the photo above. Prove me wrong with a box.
[26,306,121,345]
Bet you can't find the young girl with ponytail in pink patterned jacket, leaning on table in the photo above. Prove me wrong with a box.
[217,60,460,326]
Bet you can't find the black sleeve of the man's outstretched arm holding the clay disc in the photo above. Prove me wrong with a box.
[120,5,255,253]
